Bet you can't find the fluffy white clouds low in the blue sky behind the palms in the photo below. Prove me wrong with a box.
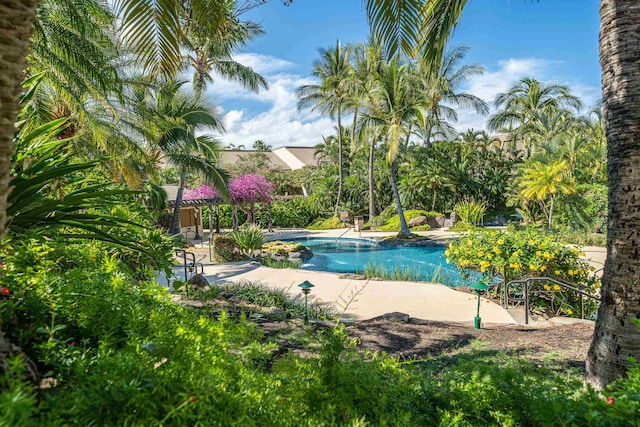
[201,53,600,148]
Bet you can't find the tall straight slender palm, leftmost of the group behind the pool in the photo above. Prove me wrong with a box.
[296,40,352,215]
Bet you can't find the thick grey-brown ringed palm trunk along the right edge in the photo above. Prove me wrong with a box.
[586,0,640,388]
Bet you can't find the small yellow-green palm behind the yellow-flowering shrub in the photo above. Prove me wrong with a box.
[520,161,576,230]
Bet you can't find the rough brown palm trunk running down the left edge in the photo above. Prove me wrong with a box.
[0,0,38,376]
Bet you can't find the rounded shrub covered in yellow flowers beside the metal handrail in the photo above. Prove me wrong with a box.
[445,229,600,316]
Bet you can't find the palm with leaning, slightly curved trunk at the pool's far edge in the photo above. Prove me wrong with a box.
[362,57,426,236]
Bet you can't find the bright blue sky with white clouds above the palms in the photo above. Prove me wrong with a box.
[208,0,601,148]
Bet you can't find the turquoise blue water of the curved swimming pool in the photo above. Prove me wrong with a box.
[294,237,461,285]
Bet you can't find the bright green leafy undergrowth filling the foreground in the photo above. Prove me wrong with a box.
[0,236,639,426]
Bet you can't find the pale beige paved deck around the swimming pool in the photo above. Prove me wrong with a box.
[158,229,606,324]
